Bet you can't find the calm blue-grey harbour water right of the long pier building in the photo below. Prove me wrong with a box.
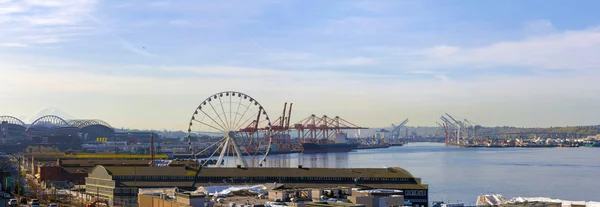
[267,143,600,203]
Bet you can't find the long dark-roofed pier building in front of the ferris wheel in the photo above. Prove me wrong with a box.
[86,166,428,206]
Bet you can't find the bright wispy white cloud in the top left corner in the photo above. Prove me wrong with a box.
[0,0,96,45]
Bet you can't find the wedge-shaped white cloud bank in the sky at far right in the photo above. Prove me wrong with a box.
[415,28,600,70]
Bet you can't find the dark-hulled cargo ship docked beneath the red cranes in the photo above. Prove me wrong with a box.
[302,132,359,153]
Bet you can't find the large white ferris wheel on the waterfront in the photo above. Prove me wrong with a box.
[188,91,271,168]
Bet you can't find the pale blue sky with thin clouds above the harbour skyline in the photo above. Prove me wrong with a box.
[0,0,600,129]
